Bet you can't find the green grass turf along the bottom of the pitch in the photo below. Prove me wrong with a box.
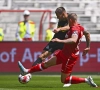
[0,75,100,90]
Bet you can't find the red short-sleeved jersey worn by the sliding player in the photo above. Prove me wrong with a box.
[62,24,84,56]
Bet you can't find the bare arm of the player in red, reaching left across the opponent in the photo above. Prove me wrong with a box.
[52,34,78,44]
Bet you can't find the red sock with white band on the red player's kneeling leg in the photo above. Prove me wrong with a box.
[64,76,85,84]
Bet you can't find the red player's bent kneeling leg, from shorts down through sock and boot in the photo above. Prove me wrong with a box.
[61,56,97,87]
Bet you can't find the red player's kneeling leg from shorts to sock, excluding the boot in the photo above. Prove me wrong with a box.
[61,55,85,84]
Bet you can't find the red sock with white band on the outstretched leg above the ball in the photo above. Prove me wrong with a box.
[28,63,46,73]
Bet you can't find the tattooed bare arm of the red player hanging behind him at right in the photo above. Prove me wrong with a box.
[82,30,90,56]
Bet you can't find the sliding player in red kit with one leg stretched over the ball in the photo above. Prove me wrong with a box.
[18,13,98,87]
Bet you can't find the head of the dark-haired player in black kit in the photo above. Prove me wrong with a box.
[55,7,68,20]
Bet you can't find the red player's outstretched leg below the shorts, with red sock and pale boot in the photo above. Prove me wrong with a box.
[18,56,56,74]
